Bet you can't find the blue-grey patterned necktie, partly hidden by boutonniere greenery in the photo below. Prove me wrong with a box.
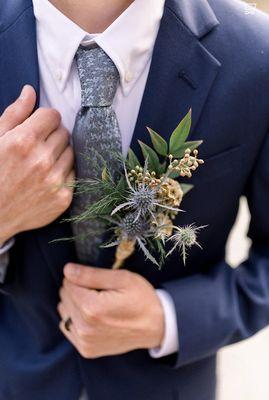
[72,47,121,264]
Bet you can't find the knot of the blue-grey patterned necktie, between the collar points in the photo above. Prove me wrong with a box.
[76,47,119,107]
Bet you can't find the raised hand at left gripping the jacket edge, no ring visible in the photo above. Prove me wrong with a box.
[0,86,74,244]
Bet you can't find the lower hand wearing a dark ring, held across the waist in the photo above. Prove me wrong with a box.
[58,264,164,358]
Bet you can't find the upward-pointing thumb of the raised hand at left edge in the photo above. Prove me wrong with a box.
[0,85,36,136]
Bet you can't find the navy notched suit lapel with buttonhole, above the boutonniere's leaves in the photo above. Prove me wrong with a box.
[131,0,220,156]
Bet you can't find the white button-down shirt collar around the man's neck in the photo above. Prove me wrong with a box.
[33,0,165,96]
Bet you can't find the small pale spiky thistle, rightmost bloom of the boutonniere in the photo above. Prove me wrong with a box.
[167,224,205,265]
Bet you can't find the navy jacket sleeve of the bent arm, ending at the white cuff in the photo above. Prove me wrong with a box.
[162,130,269,367]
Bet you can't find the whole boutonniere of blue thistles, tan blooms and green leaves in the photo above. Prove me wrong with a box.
[68,110,204,269]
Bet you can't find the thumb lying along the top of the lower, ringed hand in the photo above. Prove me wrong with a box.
[64,263,131,290]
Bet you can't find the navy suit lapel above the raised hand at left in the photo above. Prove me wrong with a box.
[0,0,39,113]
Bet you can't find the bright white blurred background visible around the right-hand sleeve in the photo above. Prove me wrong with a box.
[218,0,269,400]
